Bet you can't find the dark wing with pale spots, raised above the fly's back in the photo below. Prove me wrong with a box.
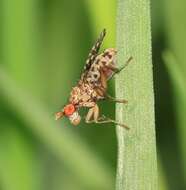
[81,29,106,81]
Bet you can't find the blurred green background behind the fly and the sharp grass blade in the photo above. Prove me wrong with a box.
[0,0,186,190]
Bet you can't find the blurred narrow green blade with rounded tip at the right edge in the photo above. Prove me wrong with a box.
[163,51,186,179]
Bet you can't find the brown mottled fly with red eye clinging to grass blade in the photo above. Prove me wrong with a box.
[55,29,132,129]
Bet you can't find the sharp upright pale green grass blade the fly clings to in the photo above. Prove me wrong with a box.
[116,0,158,190]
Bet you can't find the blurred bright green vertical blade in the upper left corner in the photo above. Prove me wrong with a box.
[1,0,40,93]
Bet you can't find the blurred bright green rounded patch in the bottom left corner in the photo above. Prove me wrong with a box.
[0,121,40,190]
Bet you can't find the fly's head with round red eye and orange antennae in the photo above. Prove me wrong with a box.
[55,104,81,125]
